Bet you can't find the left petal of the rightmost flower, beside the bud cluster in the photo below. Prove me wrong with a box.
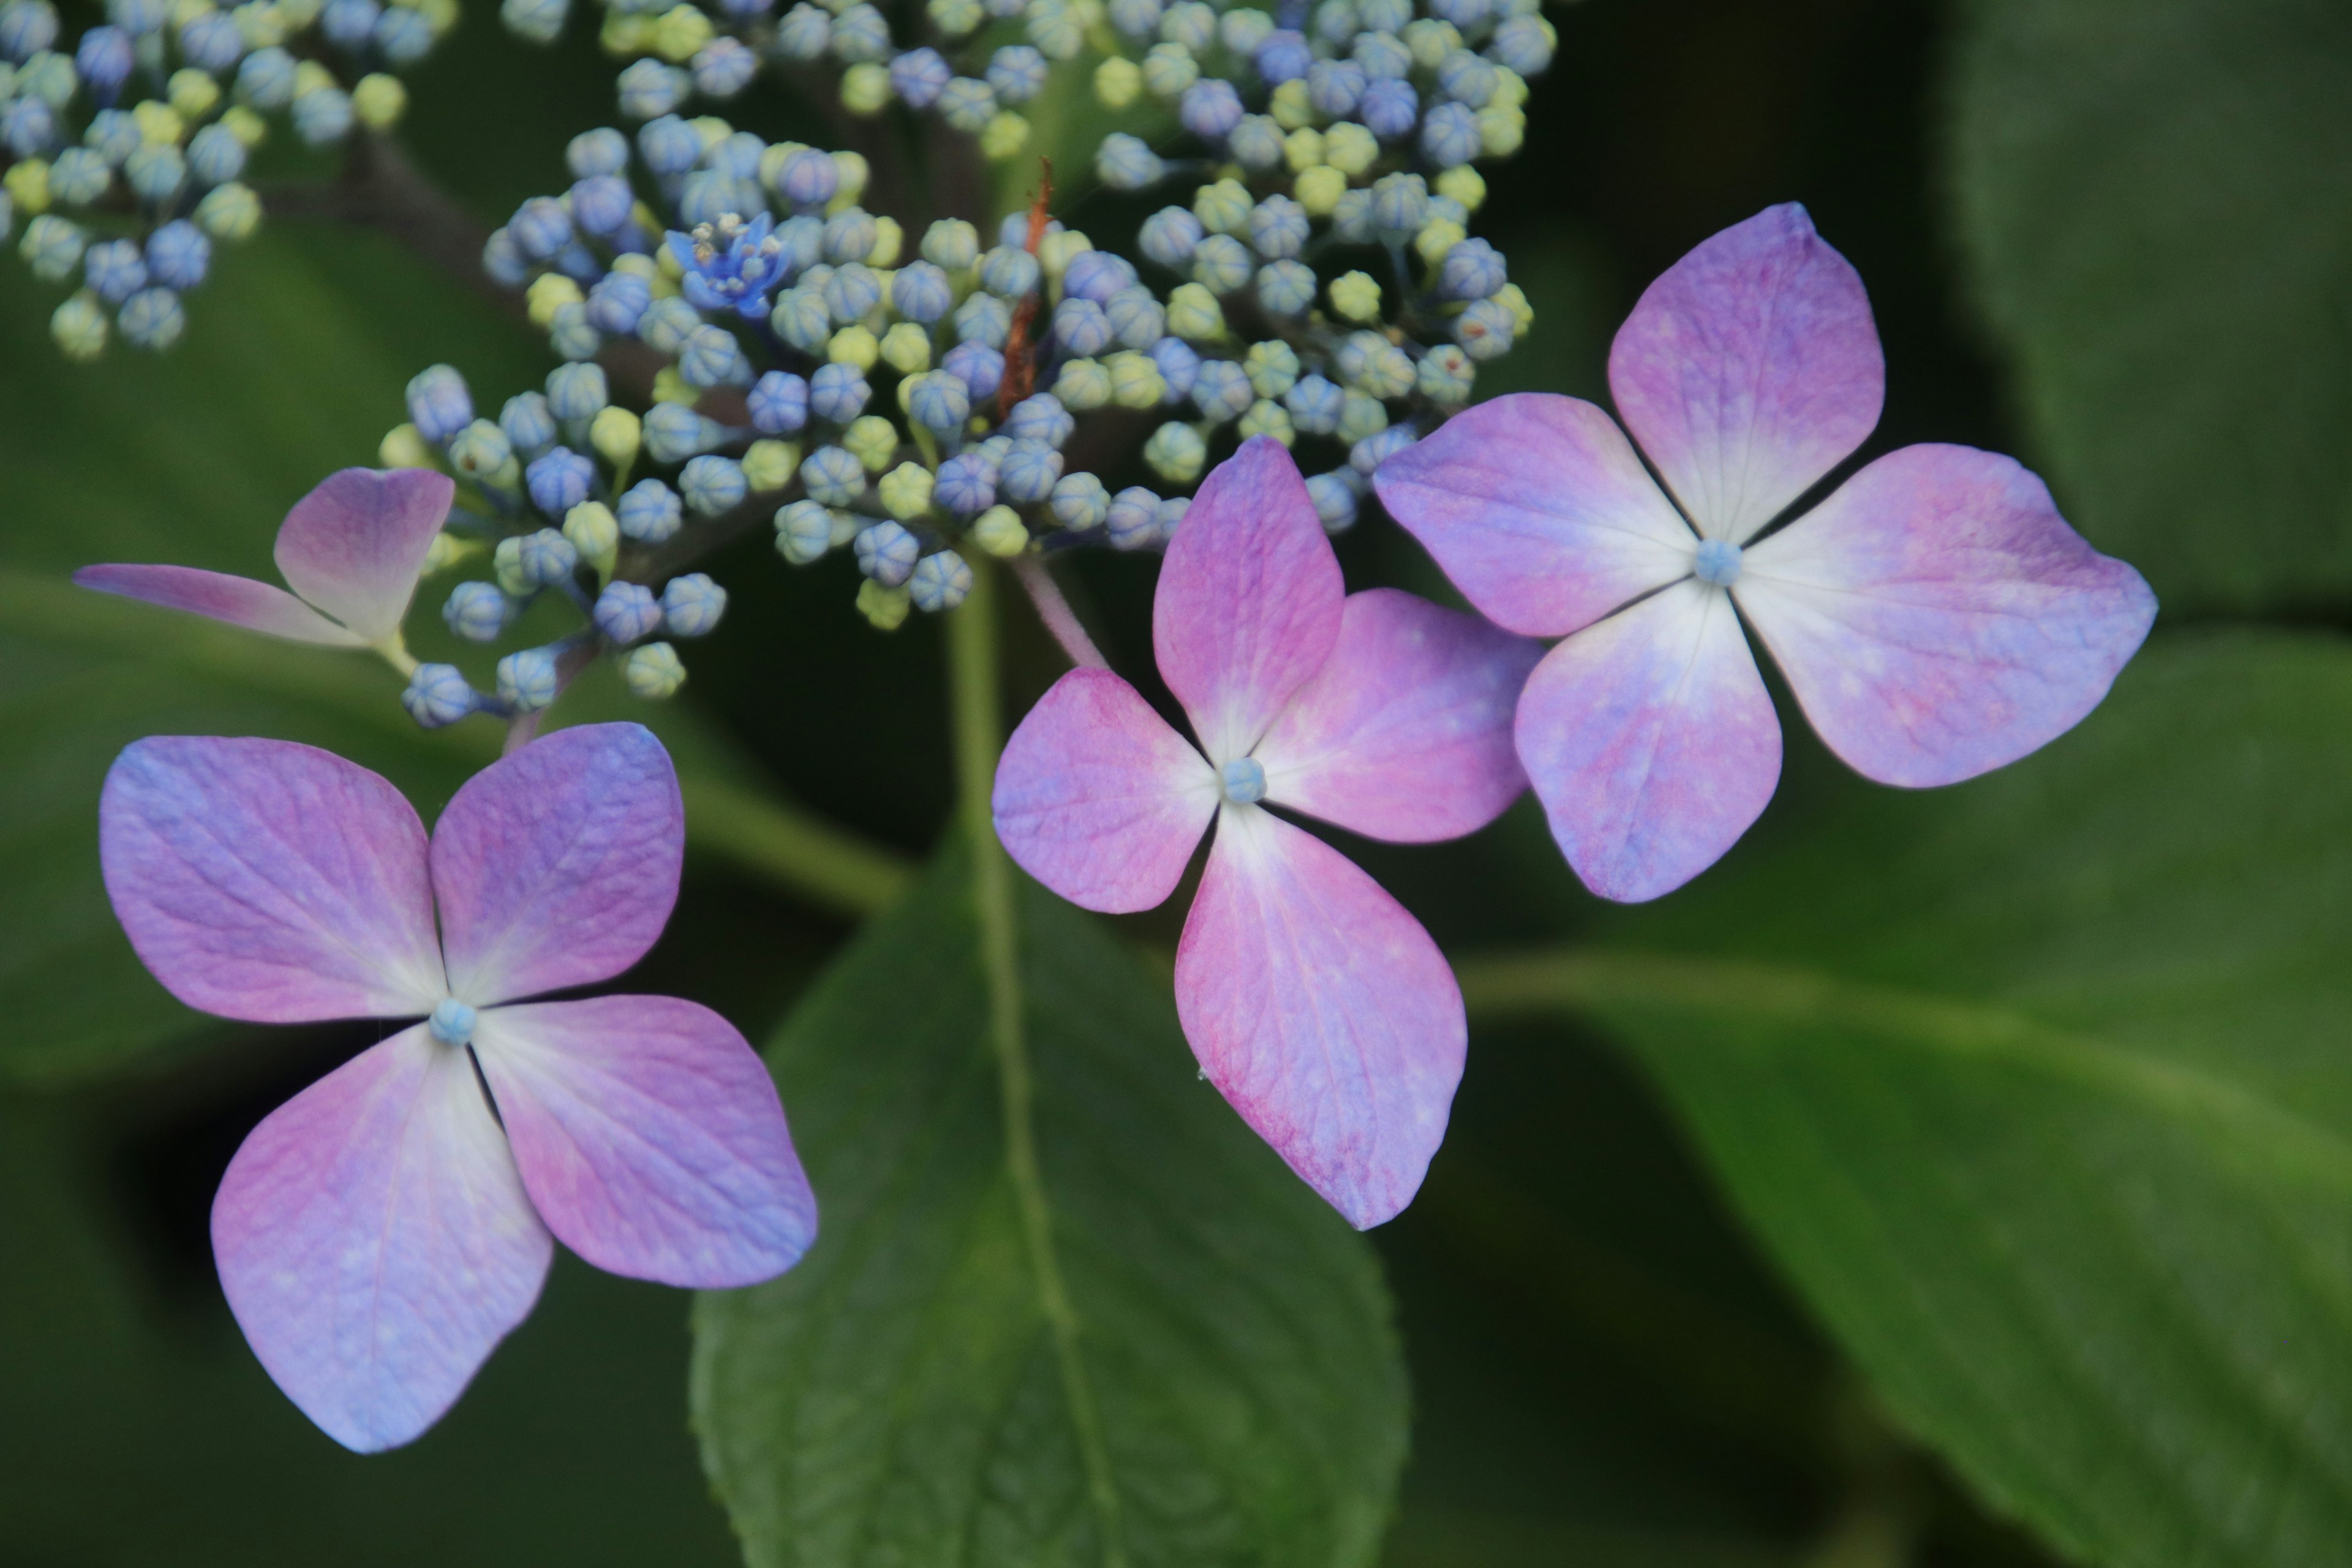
[1371,393,1698,637]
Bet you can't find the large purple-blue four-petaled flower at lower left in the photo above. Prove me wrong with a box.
[99,724,816,1453]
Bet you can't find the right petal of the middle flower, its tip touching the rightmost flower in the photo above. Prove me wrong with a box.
[1254,588,1543,844]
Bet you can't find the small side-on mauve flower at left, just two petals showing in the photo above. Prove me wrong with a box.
[73,468,456,649]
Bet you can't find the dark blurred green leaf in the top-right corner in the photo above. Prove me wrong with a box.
[1948,0,2352,609]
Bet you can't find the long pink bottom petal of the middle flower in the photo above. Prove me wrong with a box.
[1176,806,1468,1229]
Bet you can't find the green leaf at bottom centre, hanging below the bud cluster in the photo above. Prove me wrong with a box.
[692,851,1406,1568]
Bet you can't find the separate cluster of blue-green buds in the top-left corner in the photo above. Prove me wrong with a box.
[0,0,459,360]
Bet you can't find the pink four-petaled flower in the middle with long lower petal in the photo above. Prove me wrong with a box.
[992,437,1540,1227]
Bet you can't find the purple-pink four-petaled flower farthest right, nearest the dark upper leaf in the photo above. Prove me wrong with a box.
[1374,205,2157,900]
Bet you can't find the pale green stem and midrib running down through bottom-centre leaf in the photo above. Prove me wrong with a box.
[948,559,1126,1568]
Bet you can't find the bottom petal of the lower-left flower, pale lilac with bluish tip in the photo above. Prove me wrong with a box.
[212,1025,555,1453]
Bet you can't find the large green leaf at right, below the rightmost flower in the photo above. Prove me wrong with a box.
[1463,637,2352,1568]
